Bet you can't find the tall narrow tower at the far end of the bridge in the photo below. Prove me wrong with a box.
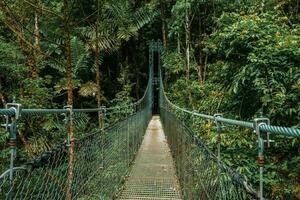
[149,40,162,115]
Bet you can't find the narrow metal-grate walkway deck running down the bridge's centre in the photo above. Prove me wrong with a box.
[120,116,181,200]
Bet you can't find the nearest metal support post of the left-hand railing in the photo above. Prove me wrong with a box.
[5,103,22,199]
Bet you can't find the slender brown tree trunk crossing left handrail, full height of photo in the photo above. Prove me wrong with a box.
[64,0,75,200]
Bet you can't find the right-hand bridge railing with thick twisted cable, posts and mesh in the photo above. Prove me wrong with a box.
[159,49,300,199]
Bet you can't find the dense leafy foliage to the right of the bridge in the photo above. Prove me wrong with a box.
[163,0,300,199]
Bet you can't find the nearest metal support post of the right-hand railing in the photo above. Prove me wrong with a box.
[254,118,270,200]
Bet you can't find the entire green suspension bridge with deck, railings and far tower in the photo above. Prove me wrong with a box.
[0,42,300,200]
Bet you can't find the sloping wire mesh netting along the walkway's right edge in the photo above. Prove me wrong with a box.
[160,108,256,200]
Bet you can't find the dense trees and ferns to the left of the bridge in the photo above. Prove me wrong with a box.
[0,0,158,178]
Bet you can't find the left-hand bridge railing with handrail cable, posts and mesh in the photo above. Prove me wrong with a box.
[0,68,153,199]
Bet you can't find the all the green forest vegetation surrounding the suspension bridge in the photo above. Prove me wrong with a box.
[0,0,300,199]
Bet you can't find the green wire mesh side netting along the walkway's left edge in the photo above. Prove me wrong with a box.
[0,106,151,199]
